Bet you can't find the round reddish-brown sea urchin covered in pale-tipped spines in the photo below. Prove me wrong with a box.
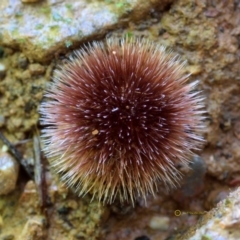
[40,39,203,203]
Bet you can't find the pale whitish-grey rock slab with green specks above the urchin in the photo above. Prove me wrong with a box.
[0,0,172,61]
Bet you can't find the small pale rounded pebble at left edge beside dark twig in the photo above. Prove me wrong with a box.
[0,152,19,195]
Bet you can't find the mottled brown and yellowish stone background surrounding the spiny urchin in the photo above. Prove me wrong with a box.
[0,0,240,240]
